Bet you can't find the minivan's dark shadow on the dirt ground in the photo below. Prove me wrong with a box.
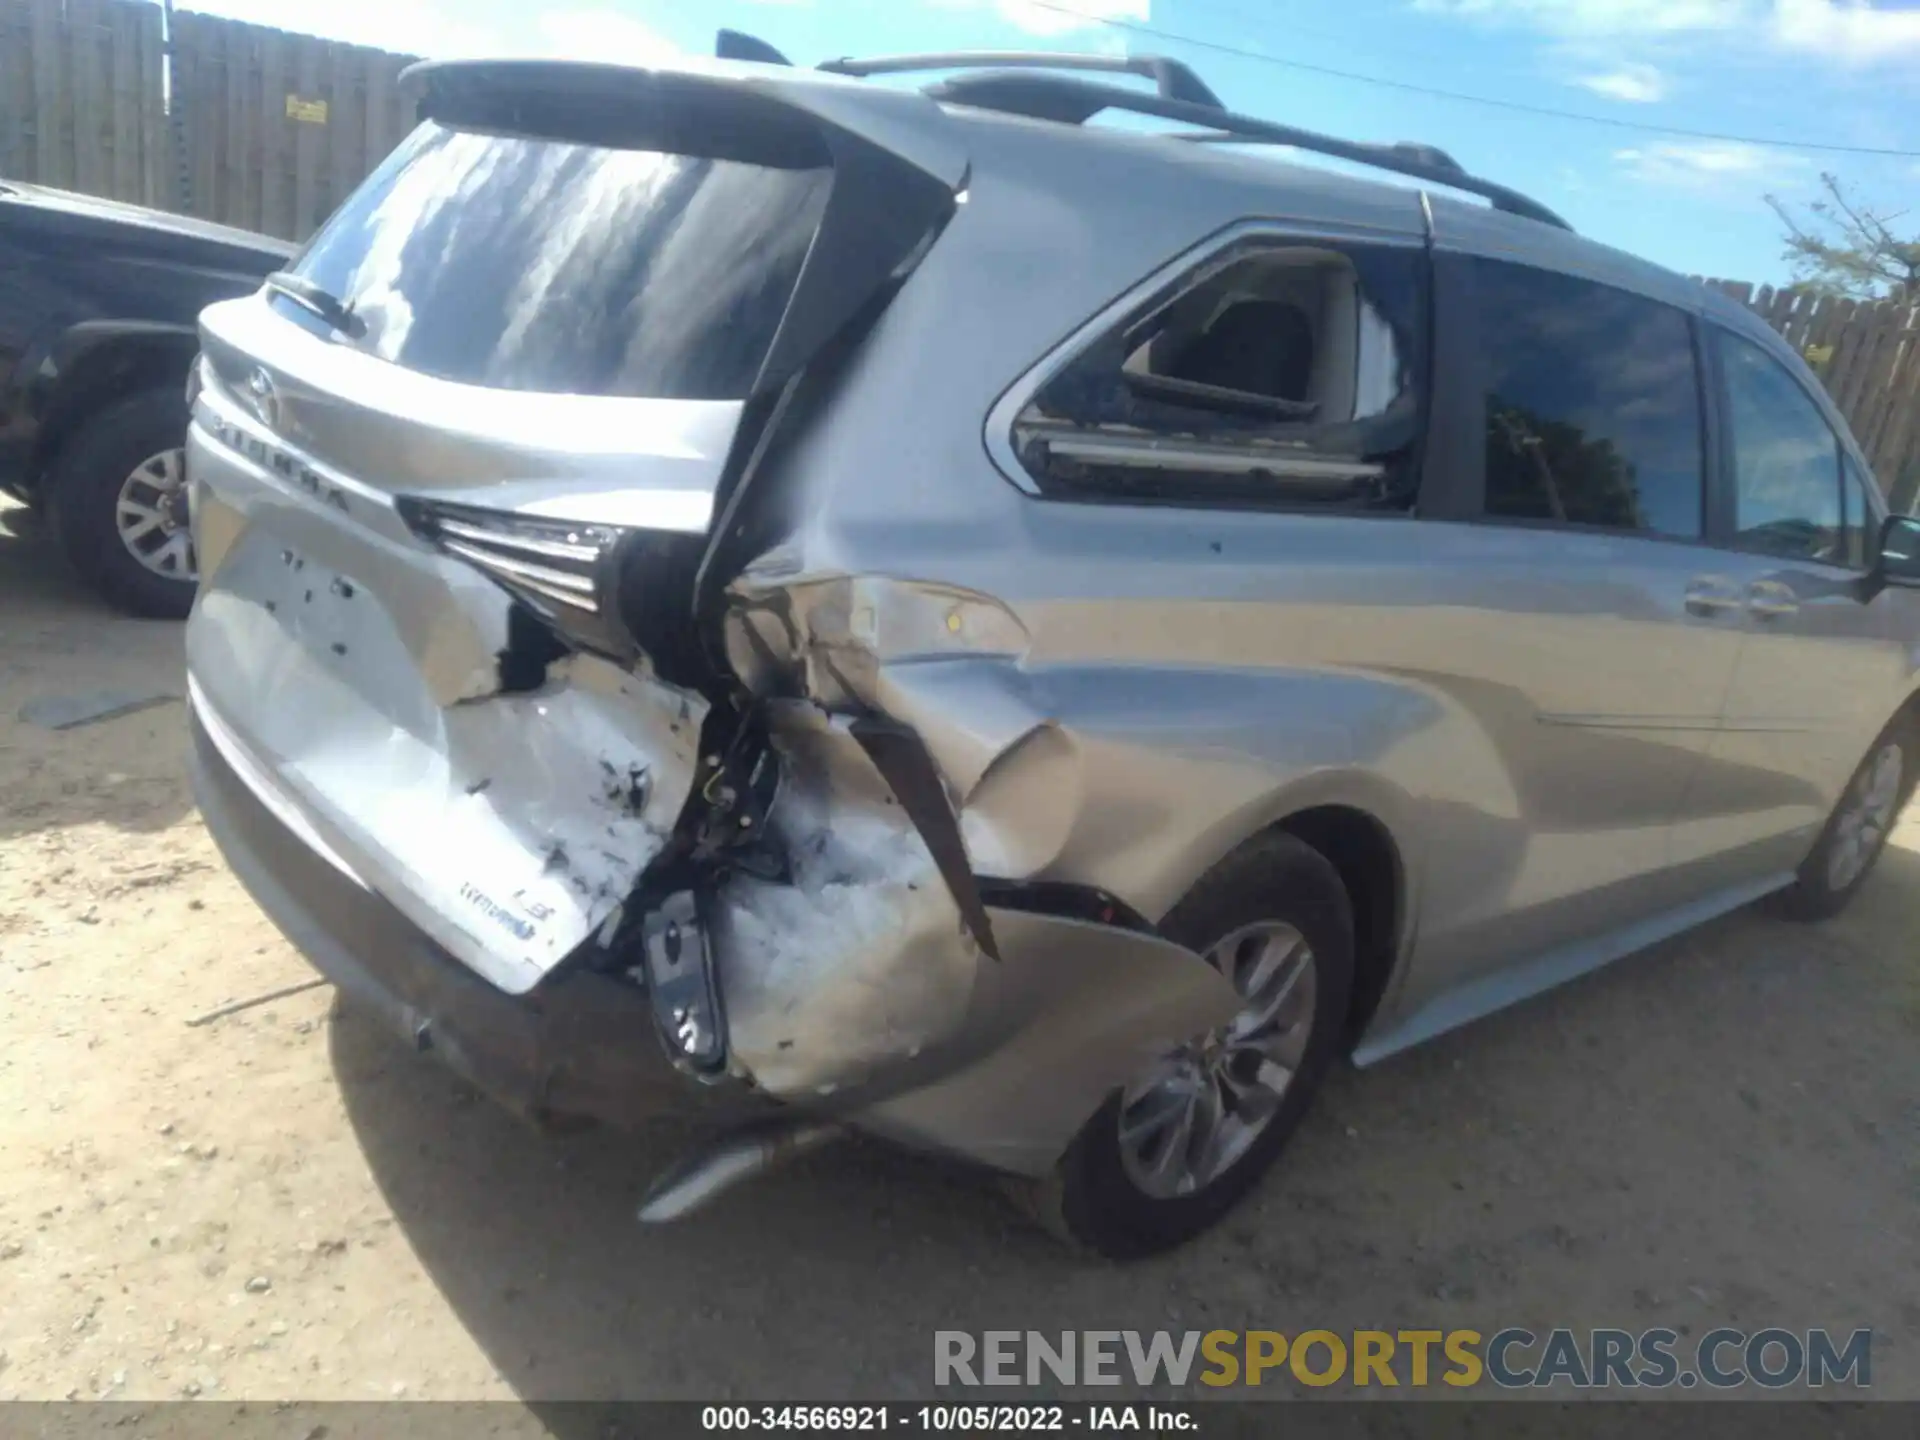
[332,851,1920,1400]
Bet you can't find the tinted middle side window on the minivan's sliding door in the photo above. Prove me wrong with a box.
[1475,261,1705,540]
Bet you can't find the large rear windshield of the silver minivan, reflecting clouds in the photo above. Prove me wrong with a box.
[273,123,831,399]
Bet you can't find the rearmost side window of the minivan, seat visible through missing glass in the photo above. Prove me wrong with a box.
[1014,240,1427,509]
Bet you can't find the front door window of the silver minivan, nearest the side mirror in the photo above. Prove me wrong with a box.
[1720,334,1849,564]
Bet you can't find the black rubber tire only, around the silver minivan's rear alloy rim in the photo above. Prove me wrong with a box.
[1027,833,1354,1260]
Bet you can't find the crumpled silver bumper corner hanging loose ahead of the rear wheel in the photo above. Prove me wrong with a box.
[712,703,1238,1173]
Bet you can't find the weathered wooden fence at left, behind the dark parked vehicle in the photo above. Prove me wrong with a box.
[0,0,413,240]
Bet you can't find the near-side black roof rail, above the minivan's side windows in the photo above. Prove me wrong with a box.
[927,69,1572,230]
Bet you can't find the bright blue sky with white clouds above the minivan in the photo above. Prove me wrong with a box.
[177,0,1920,282]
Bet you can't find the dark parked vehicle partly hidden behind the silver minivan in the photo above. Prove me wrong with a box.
[0,182,294,618]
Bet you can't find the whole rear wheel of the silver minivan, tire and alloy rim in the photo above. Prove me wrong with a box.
[1033,833,1354,1260]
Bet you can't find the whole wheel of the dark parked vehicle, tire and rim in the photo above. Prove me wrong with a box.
[46,388,198,620]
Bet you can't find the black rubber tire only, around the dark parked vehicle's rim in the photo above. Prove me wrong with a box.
[44,386,194,620]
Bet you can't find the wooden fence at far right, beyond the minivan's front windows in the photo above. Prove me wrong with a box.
[1707,280,1920,511]
